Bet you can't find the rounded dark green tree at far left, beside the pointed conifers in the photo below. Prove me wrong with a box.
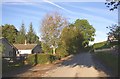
[2,24,18,43]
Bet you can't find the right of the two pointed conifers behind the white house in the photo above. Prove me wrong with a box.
[27,22,39,44]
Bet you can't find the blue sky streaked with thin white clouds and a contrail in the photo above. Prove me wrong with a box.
[2,0,118,42]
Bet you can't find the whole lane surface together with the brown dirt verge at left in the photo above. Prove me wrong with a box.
[4,53,113,78]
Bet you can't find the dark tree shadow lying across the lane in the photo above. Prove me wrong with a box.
[59,53,113,77]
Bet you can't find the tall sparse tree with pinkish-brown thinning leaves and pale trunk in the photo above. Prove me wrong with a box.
[41,12,68,54]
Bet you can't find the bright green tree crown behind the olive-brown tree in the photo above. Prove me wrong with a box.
[74,19,95,46]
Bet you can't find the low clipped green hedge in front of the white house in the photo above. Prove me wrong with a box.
[26,54,57,64]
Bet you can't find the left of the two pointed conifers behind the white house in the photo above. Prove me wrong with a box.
[16,23,26,44]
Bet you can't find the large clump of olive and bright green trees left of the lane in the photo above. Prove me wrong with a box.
[57,19,95,56]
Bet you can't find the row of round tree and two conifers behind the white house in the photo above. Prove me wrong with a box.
[2,23,39,44]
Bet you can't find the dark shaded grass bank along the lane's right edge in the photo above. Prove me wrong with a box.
[95,51,118,74]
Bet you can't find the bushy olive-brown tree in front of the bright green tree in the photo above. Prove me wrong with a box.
[60,27,84,54]
